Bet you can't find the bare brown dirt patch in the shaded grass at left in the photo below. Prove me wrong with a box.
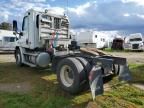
[0,82,31,93]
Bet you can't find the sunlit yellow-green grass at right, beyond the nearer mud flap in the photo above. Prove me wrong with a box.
[94,64,144,108]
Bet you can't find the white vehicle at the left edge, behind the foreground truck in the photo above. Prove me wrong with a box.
[0,30,16,51]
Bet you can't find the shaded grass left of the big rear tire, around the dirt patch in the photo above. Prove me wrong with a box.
[0,63,91,108]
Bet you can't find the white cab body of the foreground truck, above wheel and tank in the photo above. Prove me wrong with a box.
[15,9,69,49]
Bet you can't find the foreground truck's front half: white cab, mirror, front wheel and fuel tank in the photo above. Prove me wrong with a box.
[13,9,70,67]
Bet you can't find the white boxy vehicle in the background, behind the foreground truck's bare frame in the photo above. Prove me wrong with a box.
[75,31,106,49]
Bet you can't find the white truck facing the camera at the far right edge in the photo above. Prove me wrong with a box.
[124,33,144,51]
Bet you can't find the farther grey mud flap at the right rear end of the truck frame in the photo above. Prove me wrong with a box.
[119,64,132,81]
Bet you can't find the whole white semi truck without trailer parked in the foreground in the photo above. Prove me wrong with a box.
[13,9,131,97]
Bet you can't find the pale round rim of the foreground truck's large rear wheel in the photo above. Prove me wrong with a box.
[60,65,74,87]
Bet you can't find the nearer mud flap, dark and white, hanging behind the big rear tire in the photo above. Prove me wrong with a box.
[89,66,104,100]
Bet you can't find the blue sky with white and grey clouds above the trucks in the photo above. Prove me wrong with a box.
[0,0,144,33]
